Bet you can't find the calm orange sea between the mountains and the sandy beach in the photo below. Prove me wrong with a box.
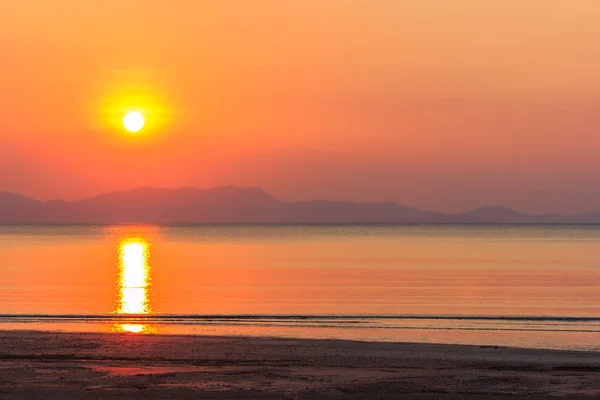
[0,225,600,350]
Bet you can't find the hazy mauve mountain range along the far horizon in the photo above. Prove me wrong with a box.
[0,186,600,224]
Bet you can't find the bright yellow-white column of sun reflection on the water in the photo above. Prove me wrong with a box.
[116,237,152,333]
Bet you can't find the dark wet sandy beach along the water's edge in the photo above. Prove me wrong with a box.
[0,331,600,399]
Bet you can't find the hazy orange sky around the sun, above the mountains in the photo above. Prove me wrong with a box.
[0,0,600,212]
